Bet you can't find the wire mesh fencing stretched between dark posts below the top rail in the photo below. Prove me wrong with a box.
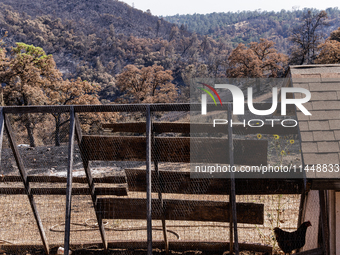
[0,104,314,254]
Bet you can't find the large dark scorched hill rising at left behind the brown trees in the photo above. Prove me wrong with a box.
[0,0,224,101]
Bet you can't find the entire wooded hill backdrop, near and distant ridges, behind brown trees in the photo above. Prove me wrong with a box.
[0,0,340,103]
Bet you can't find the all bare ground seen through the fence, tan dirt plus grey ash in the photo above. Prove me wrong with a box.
[0,141,299,254]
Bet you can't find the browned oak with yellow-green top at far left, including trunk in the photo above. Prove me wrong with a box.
[0,43,62,147]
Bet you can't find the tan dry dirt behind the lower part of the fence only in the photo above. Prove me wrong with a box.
[0,190,292,254]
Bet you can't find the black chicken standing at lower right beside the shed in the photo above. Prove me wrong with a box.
[274,221,312,254]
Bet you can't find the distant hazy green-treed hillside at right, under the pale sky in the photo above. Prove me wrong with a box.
[164,8,340,53]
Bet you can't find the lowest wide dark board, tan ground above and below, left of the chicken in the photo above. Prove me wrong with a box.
[97,198,264,224]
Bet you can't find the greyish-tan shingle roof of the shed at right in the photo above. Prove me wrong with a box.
[290,65,340,178]
